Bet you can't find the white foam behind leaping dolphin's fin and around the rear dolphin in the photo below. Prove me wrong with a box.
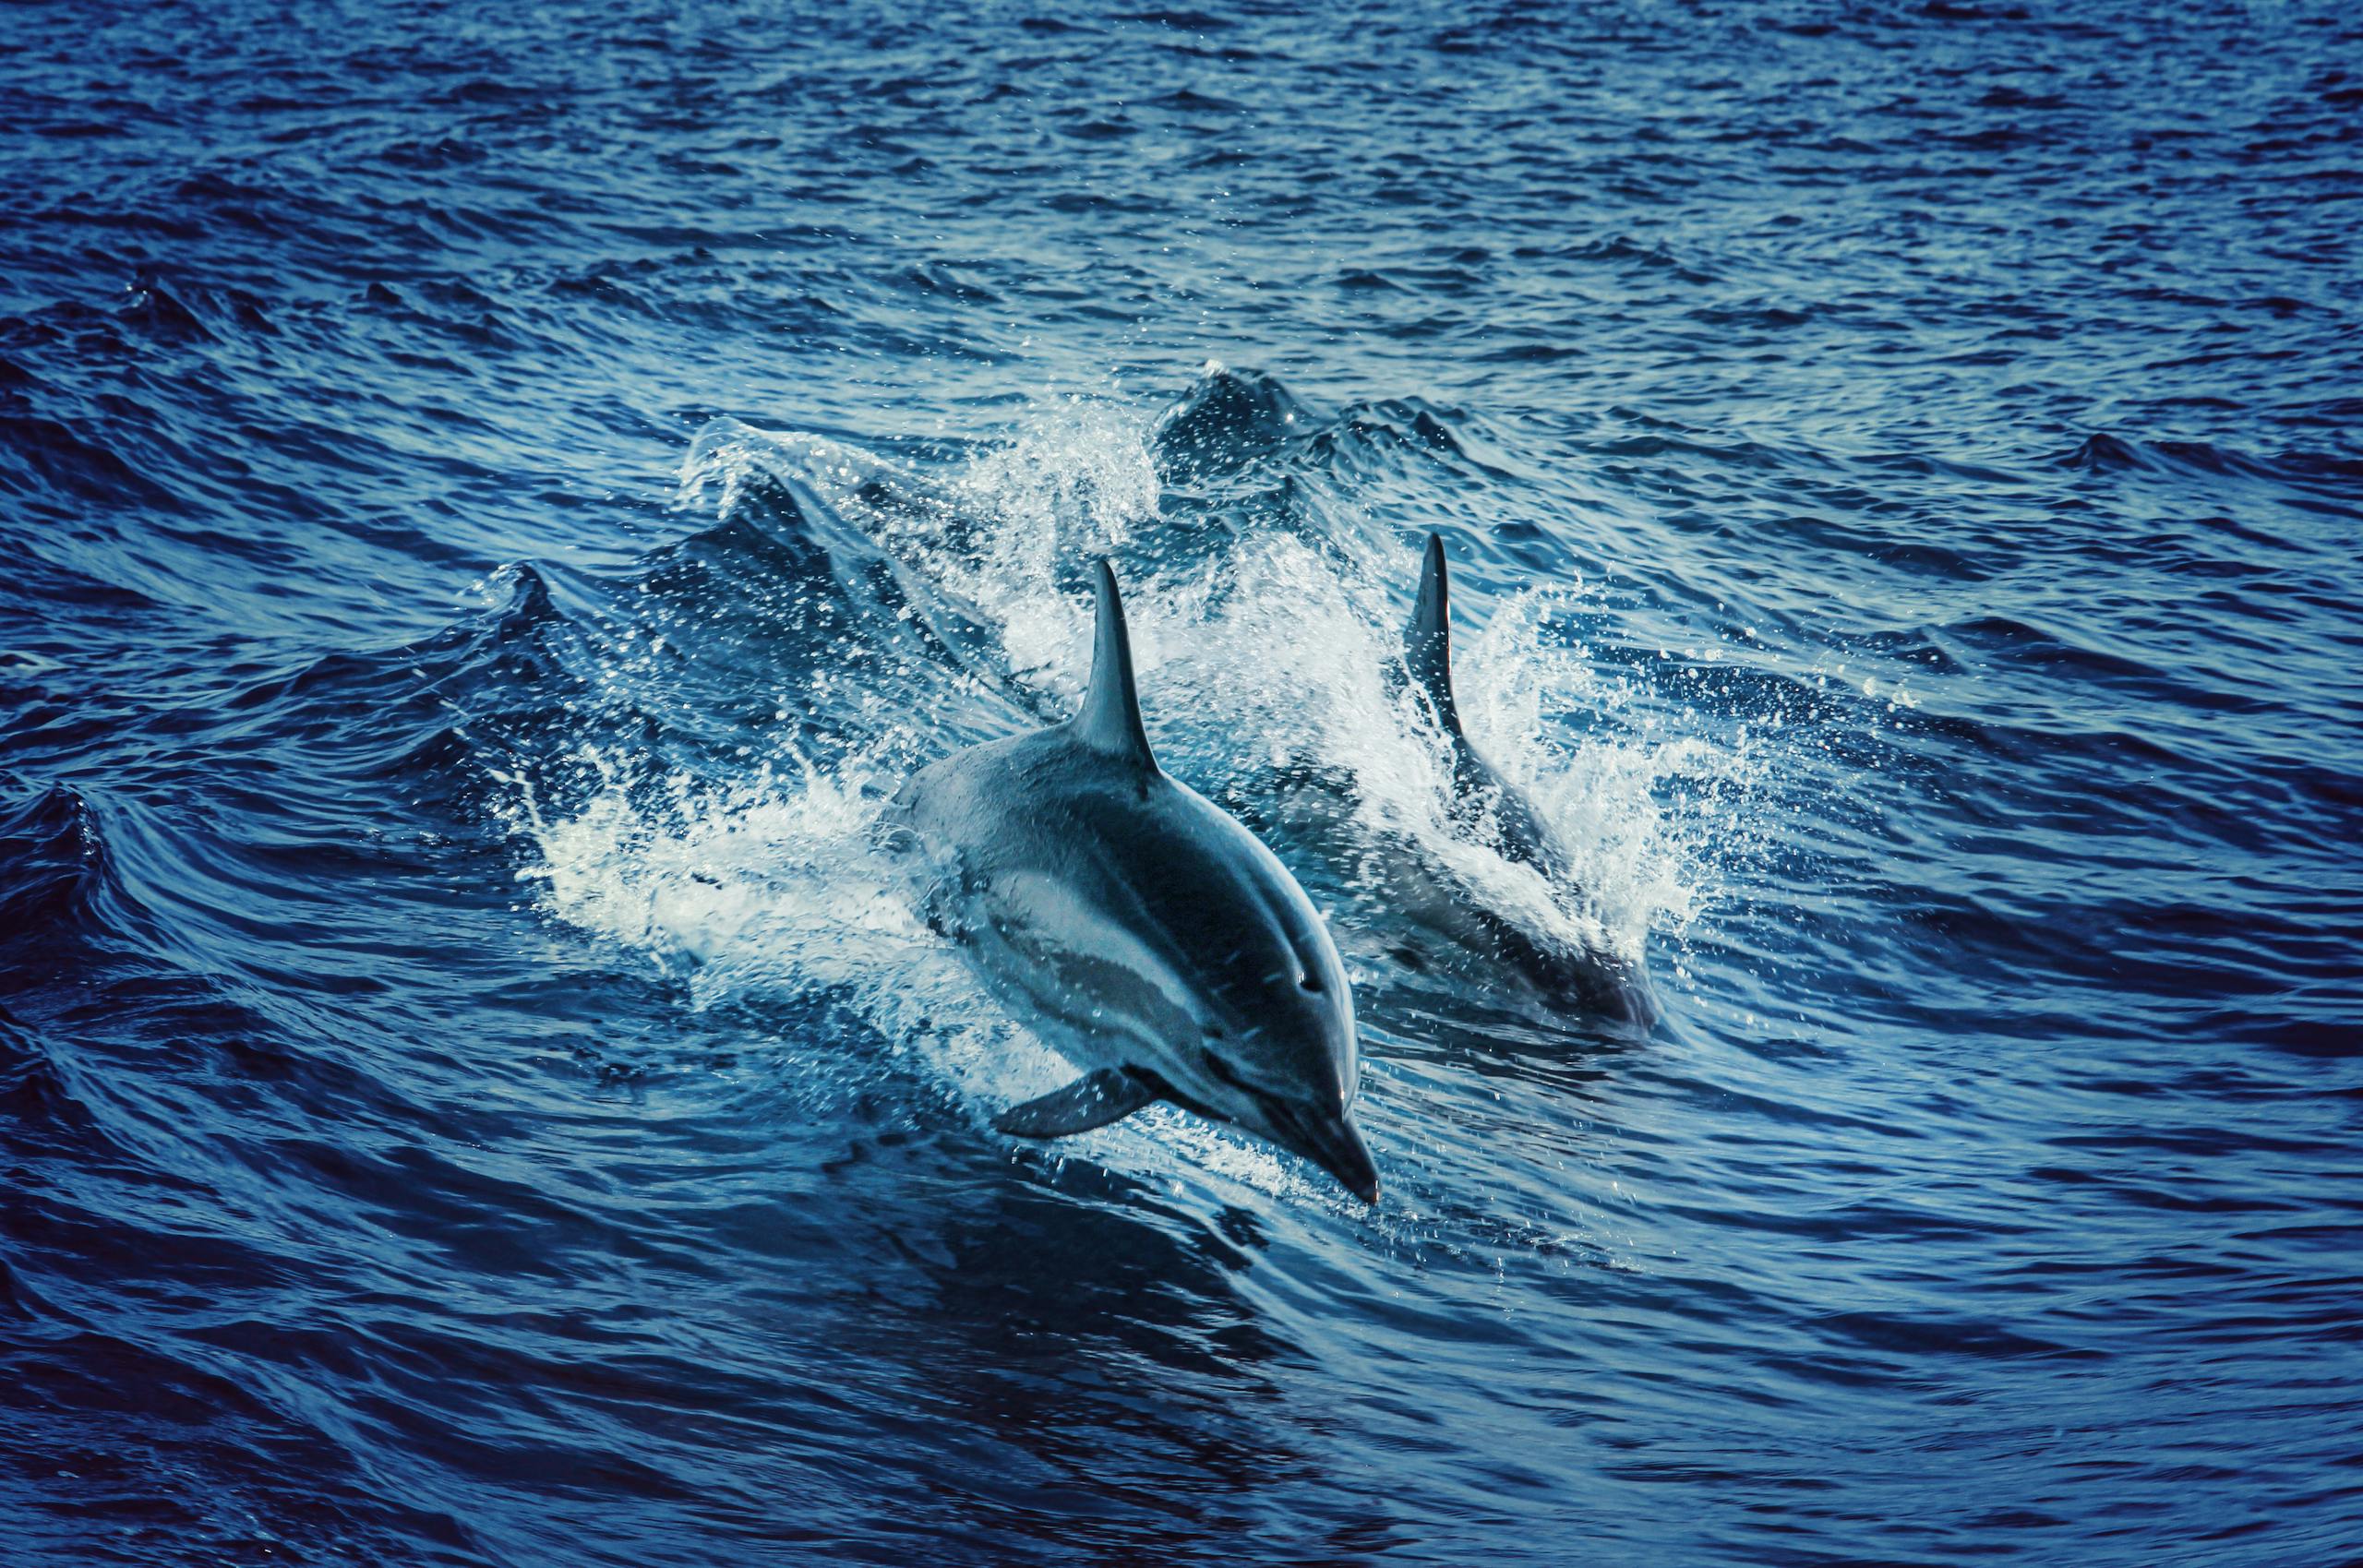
[683,397,1754,973]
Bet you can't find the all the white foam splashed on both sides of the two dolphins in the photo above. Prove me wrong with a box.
[510,379,1758,1152]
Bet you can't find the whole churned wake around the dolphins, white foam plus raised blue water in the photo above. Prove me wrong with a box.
[501,368,1758,1190]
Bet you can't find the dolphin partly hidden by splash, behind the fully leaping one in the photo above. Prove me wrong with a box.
[1404,533,1657,1030]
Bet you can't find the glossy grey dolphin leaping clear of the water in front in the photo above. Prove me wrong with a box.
[895,562,1377,1202]
